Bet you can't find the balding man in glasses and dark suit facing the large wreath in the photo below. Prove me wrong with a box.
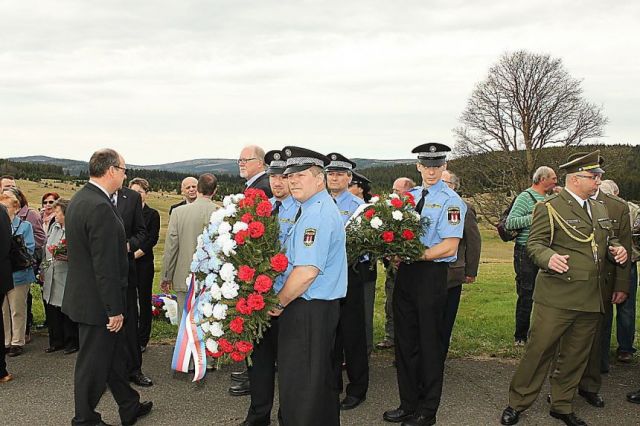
[62,149,153,426]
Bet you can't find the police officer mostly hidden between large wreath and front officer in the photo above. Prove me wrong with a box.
[237,150,300,426]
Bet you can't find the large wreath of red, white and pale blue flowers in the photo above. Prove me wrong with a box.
[174,189,289,376]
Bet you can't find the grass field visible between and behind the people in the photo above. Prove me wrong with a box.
[18,181,640,358]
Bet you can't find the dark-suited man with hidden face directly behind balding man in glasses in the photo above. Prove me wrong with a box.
[116,187,153,386]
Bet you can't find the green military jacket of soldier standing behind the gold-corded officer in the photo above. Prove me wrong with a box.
[596,191,631,300]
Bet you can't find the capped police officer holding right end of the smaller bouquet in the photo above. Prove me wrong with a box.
[383,143,466,426]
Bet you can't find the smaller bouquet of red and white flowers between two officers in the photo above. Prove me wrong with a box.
[346,193,424,264]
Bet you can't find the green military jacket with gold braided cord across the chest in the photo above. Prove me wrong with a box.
[527,189,620,312]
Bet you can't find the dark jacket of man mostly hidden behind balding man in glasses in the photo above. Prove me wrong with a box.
[117,187,147,288]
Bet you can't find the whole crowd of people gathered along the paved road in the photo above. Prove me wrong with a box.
[0,143,640,426]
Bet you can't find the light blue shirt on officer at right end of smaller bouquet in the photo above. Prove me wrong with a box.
[409,180,467,262]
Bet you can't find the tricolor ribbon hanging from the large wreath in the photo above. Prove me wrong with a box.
[171,274,207,382]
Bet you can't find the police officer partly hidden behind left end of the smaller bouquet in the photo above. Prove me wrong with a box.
[325,152,370,410]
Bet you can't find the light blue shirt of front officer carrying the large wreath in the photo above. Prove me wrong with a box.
[274,190,347,300]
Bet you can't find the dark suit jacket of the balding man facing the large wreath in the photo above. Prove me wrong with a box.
[62,183,129,325]
